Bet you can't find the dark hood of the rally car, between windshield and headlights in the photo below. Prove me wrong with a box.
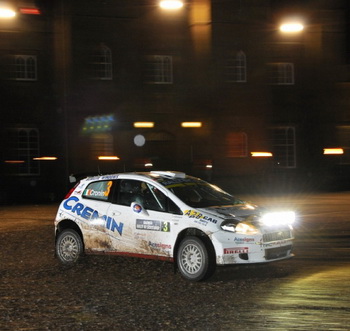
[199,204,261,220]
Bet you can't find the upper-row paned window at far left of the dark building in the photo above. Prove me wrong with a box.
[11,55,37,81]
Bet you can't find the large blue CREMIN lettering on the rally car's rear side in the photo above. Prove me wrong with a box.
[63,196,124,235]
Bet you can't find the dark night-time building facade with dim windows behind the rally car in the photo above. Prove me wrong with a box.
[0,0,350,203]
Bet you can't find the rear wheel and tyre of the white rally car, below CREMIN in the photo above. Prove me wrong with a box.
[56,229,84,265]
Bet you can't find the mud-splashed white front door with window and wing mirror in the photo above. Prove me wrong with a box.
[109,179,182,257]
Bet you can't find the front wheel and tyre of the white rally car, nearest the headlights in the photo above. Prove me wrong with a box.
[176,236,216,281]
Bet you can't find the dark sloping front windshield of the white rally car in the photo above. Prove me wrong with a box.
[162,177,243,208]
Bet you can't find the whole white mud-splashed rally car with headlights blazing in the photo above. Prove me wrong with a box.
[55,171,295,281]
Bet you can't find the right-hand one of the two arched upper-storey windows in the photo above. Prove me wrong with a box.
[225,51,247,83]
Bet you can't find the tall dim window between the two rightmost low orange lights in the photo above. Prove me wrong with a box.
[272,127,296,168]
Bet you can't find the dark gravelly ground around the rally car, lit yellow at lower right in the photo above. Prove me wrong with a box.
[0,193,350,330]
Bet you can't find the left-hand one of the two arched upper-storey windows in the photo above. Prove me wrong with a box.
[90,44,113,80]
